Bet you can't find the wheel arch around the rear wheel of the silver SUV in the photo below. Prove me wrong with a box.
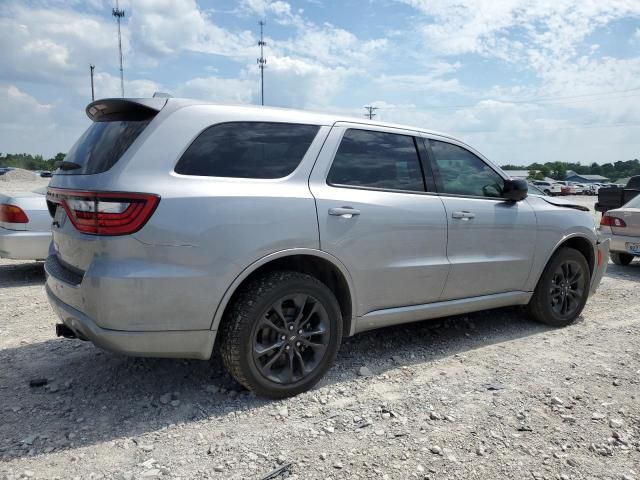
[211,248,357,336]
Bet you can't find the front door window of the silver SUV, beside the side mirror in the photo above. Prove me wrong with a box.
[430,140,504,198]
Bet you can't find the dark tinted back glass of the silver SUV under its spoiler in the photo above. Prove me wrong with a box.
[56,120,151,175]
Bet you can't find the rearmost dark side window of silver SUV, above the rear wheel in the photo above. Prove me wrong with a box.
[175,122,320,179]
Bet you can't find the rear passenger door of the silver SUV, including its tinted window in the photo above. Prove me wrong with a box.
[310,123,449,316]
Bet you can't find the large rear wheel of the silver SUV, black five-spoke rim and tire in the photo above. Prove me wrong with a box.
[220,271,342,398]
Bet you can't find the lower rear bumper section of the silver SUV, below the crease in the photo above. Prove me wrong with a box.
[46,285,216,360]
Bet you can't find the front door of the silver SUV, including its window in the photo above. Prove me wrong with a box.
[425,139,537,300]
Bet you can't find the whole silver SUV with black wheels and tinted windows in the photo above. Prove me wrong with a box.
[46,98,608,397]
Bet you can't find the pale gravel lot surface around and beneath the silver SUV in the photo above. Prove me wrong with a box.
[0,195,640,480]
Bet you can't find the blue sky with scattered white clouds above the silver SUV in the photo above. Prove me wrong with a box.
[0,0,640,165]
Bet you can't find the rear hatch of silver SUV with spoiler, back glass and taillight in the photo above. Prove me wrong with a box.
[47,98,167,274]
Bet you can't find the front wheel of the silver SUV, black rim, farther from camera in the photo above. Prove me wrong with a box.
[527,247,591,327]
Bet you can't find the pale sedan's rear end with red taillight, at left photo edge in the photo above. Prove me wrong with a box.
[0,188,51,260]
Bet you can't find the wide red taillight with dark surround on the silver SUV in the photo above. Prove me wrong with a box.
[47,188,160,235]
